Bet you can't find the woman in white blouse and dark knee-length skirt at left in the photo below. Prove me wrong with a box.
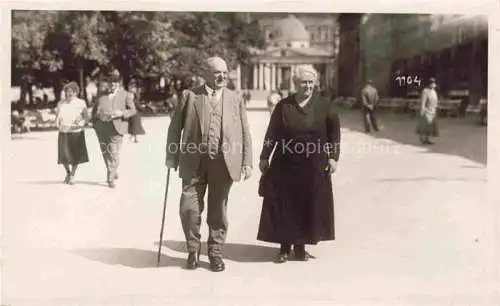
[56,82,90,185]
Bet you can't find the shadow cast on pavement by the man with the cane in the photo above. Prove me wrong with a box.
[72,248,185,269]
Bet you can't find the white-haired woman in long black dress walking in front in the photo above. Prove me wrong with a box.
[257,66,340,263]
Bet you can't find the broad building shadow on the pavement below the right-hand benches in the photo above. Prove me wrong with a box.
[339,108,487,166]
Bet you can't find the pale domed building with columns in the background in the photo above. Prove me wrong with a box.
[236,13,338,92]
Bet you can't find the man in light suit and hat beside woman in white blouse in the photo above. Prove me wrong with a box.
[92,71,137,188]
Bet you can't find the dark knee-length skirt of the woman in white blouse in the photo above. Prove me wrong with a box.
[57,131,89,165]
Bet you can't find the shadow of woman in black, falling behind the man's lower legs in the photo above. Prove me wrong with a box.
[156,240,279,262]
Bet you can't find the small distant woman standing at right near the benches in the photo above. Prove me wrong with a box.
[416,78,439,145]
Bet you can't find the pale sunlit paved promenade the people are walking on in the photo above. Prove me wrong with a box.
[2,111,500,306]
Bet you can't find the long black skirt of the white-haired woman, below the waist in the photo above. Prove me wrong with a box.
[257,154,335,244]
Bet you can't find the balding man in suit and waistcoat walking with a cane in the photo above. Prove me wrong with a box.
[166,57,252,272]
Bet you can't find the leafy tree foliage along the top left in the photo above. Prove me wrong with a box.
[12,11,264,83]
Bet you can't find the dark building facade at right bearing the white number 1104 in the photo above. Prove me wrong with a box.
[359,14,488,103]
